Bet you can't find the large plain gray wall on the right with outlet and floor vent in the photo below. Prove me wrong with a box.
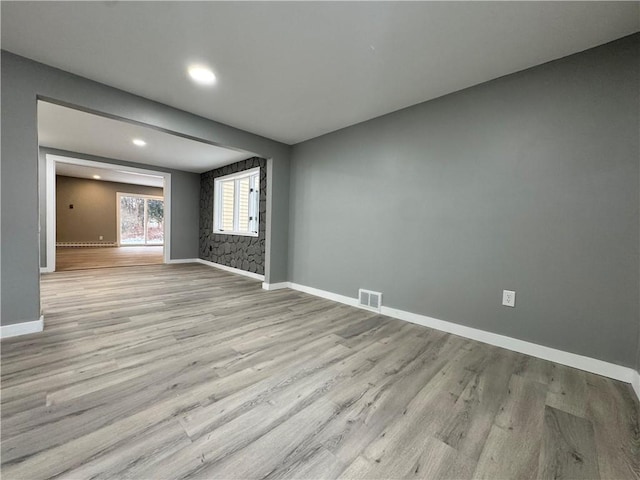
[289,35,640,366]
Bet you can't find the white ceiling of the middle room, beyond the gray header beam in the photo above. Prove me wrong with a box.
[38,101,254,173]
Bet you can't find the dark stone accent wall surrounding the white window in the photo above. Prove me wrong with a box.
[200,157,267,275]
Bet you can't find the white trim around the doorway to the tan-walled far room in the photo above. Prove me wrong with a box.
[40,153,171,272]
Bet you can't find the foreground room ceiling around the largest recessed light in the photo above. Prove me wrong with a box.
[1,1,640,143]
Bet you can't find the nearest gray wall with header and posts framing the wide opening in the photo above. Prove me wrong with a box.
[0,50,290,325]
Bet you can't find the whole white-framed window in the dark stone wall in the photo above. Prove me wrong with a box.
[213,167,260,237]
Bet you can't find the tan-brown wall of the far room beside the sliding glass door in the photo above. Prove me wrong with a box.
[56,175,162,244]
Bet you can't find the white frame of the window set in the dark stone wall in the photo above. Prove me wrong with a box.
[213,167,260,237]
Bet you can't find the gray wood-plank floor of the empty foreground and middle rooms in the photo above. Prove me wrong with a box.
[1,264,640,480]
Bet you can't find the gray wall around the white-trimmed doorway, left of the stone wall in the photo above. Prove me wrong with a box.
[39,147,200,267]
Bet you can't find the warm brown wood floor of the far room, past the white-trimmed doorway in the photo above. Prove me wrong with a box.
[56,245,164,272]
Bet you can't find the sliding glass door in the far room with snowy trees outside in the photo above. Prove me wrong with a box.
[117,192,164,245]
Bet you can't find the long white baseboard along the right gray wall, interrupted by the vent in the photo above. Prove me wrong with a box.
[278,282,640,399]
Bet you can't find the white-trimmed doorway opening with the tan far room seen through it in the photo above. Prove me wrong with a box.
[42,154,171,272]
